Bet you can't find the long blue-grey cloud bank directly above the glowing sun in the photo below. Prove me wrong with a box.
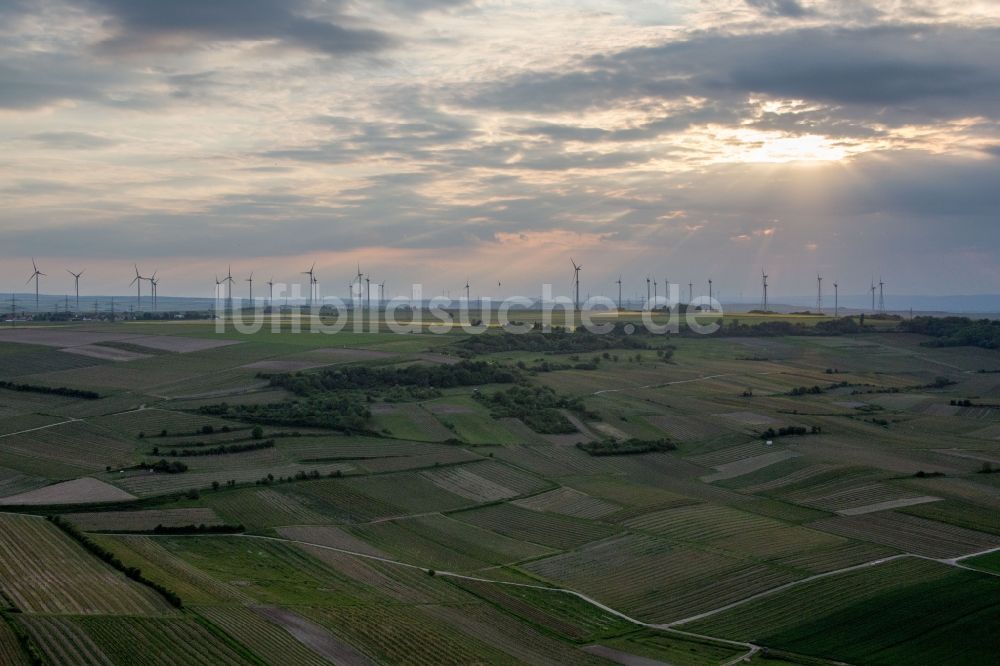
[466,26,1000,122]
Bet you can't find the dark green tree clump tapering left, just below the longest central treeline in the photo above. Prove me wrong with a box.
[198,394,371,433]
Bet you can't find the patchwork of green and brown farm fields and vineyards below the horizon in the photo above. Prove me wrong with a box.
[0,318,1000,666]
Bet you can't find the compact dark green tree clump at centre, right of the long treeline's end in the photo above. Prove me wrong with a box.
[475,385,597,435]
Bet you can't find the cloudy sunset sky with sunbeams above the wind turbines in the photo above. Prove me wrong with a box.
[0,0,1000,300]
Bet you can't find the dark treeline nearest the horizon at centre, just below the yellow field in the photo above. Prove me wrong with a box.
[456,325,650,356]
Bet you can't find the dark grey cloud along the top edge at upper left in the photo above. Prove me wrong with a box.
[84,0,393,55]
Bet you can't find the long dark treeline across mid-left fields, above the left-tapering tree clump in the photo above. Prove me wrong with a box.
[270,360,521,397]
